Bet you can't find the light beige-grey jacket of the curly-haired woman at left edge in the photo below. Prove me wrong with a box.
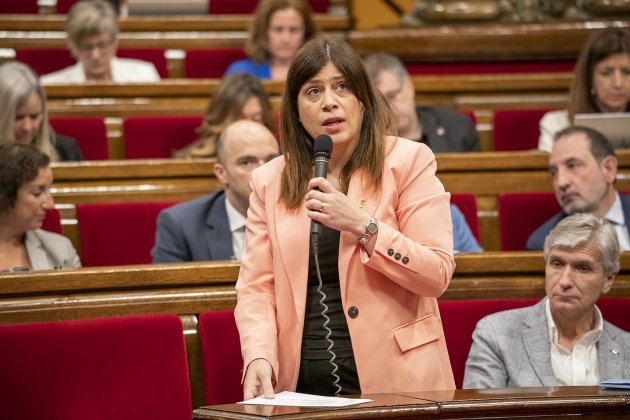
[24,229,81,270]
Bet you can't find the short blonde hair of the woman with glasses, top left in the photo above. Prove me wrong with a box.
[66,0,118,48]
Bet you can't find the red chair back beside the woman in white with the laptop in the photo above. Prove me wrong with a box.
[494,109,549,151]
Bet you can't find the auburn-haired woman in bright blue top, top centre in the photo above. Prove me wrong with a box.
[225,0,316,80]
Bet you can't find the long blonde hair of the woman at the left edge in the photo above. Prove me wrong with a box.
[0,62,59,162]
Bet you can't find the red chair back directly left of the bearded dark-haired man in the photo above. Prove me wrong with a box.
[498,192,561,251]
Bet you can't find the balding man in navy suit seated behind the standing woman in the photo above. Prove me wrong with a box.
[151,120,279,263]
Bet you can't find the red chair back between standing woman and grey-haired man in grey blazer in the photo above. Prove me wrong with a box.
[438,296,542,388]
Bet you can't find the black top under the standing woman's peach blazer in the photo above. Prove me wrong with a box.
[302,226,353,360]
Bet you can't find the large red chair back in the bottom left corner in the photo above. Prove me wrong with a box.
[0,315,192,420]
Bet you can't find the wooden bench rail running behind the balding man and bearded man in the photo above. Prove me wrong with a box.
[52,150,630,251]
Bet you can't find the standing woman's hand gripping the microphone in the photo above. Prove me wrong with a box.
[306,178,370,239]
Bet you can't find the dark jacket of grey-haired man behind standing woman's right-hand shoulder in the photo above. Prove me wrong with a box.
[412,106,481,153]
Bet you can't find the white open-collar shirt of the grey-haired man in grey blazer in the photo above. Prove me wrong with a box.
[545,300,604,386]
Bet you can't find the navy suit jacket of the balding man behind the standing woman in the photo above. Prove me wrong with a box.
[151,191,234,263]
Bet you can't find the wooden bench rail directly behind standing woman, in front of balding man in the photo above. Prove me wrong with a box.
[0,252,630,407]
